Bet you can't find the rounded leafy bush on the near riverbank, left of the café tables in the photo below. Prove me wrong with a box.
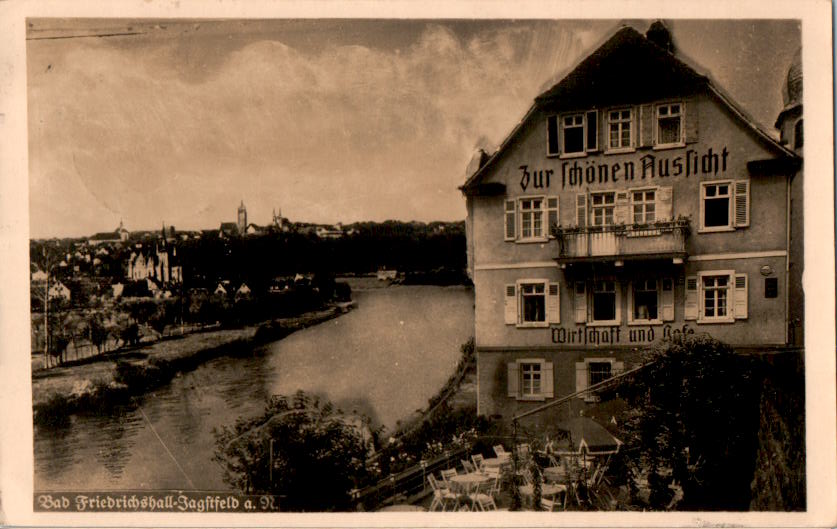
[214,391,369,511]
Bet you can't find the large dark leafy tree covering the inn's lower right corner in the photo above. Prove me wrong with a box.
[619,335,759,510]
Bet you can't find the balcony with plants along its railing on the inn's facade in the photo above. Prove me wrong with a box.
[552,219,689,266]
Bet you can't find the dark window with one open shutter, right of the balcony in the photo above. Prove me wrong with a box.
[699,180,750,232]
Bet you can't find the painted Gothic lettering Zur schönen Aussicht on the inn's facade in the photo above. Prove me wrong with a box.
[519,147,729,191]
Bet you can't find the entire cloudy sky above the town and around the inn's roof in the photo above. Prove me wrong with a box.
[27,19,801,238]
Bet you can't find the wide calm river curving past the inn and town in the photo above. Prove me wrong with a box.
[34,286,474,491]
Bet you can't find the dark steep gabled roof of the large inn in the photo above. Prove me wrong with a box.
[460,27,797,194]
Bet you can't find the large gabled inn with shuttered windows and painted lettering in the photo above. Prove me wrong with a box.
[461,22,802,432]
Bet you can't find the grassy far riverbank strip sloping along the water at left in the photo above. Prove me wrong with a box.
[32,303,354,425]
